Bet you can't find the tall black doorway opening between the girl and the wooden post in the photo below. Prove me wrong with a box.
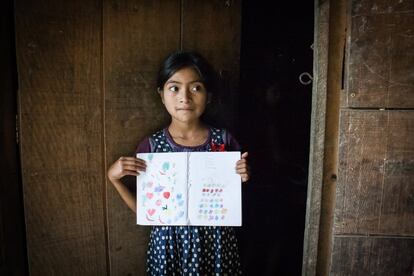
[237,1,314,275]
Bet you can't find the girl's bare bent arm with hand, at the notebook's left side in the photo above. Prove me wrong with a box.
[108,157,146,213]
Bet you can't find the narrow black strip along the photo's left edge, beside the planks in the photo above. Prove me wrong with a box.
[0,1,28,275]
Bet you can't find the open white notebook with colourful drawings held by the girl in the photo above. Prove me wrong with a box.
[137,152,242,226]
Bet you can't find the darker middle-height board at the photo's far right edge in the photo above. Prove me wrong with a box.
[378,111,414,236]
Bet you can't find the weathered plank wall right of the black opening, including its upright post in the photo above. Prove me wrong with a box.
[303,0,414,275]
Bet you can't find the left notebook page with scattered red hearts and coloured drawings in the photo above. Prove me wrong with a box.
[137,153,187,225]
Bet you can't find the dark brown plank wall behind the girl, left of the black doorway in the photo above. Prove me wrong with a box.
[15,0,241,275]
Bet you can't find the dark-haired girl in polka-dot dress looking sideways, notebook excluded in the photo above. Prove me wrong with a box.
[108,52,250,275]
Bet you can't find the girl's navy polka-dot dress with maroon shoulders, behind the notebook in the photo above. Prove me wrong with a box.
[136,127,241,275]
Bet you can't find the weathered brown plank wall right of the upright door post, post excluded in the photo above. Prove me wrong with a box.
[331,0,414,275]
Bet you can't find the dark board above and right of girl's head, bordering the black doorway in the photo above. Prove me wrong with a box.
[181,0,241,128]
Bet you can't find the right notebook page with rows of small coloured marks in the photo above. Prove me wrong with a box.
[188,152,242,226]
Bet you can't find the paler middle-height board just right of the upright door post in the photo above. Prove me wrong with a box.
[334,110,387,233]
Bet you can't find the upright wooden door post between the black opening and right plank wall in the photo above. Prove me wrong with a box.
[302,0,347,275]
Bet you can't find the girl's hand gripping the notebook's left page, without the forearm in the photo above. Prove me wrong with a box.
[108,157,147,181]
